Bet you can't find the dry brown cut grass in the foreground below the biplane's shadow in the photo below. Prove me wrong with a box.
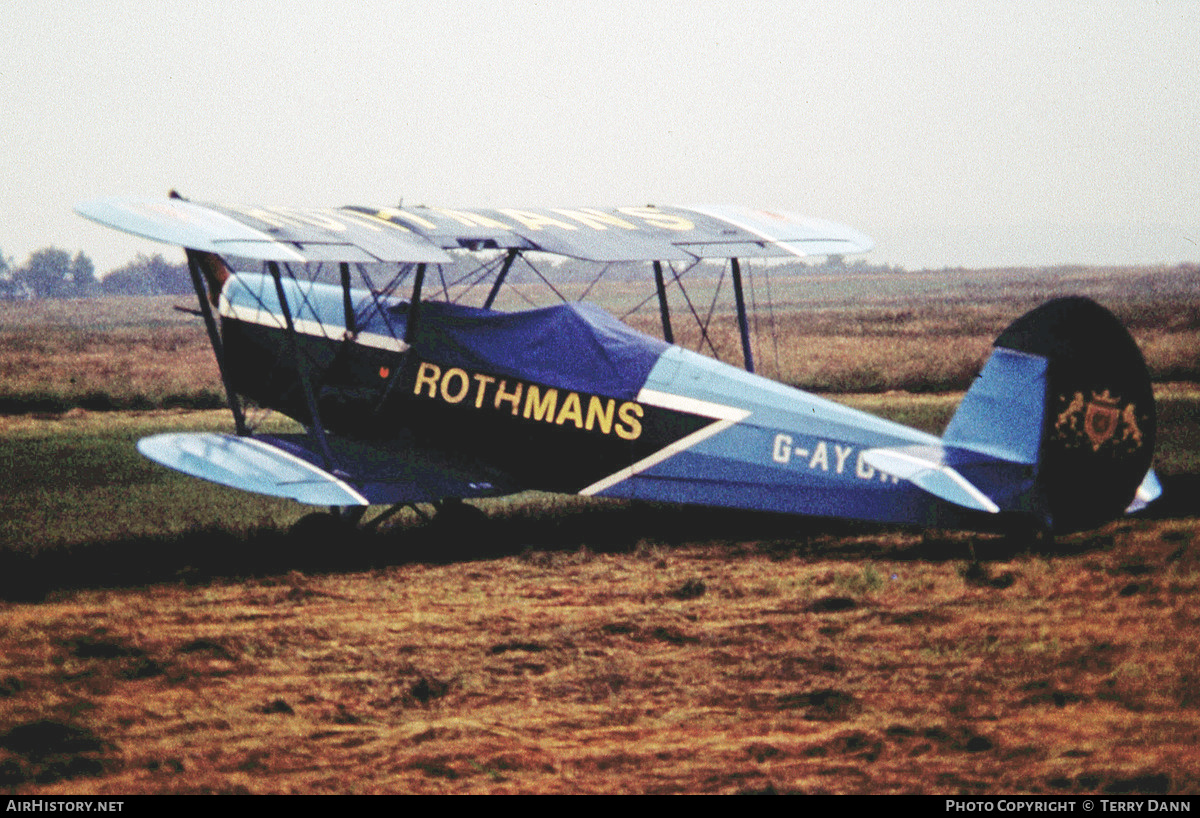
[0,521,1200,793]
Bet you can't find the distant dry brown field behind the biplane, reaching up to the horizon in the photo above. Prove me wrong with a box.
[0,265,1200,414]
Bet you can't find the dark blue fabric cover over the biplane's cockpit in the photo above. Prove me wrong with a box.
[406,301,667,399]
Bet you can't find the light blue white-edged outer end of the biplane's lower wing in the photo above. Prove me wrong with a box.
[138,432,370,506]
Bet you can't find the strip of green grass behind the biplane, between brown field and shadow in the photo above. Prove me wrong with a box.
[0,390,1200,561]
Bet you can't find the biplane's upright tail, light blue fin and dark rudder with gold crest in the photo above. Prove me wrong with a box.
[942,297,1157,531]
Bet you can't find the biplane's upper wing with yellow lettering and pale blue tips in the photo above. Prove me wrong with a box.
[76,198,874,264]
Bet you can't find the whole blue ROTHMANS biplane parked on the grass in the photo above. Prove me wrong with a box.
[77,193,1160,531]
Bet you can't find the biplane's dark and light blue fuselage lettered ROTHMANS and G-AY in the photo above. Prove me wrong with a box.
[221,273,974,524]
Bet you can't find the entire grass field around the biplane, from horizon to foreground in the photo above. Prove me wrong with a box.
[0,270,1200,795]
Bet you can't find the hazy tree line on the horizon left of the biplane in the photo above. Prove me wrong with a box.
[0,247,192,301]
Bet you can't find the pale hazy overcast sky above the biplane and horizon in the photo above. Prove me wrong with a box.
[0,0,1200,273]
